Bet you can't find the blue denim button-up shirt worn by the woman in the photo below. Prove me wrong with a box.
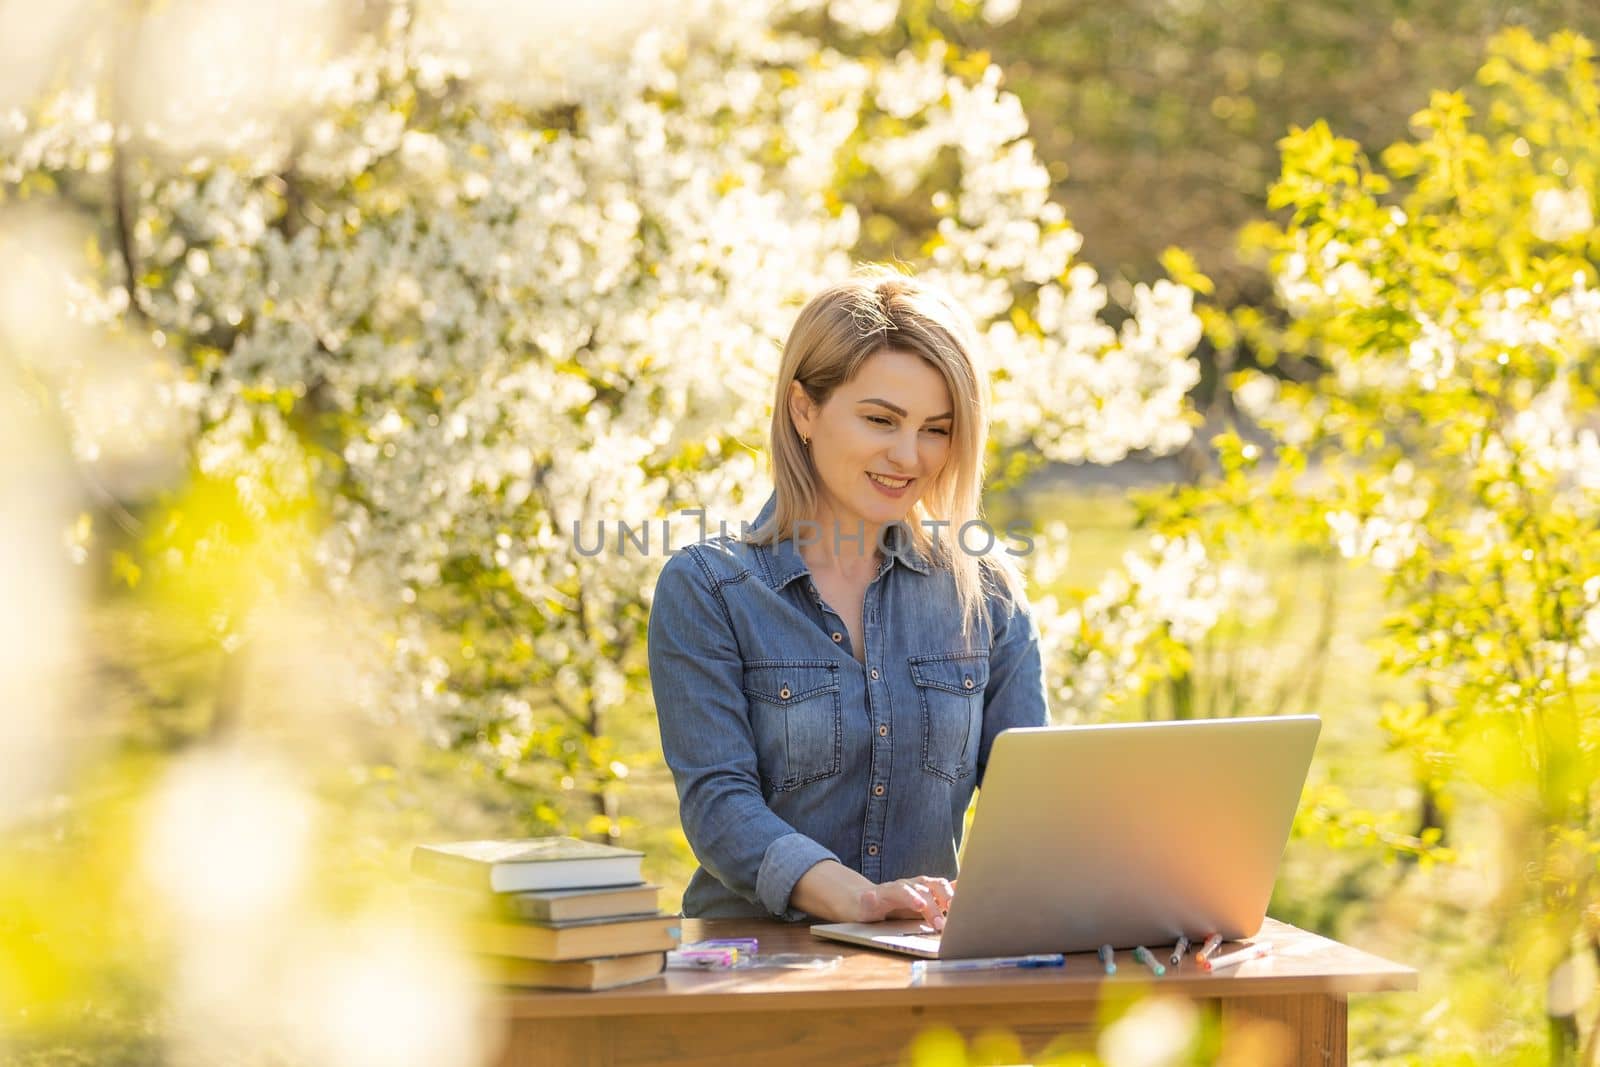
[648,498,1048,921]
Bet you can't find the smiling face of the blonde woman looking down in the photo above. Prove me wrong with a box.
[790,349,954,537]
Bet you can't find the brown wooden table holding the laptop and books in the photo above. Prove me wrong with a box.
[494,918,1416,1067]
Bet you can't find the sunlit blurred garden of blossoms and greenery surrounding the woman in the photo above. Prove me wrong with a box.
[9,0,1600,1067]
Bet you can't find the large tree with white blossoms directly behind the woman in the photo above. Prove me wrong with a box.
[0,0,1198,833]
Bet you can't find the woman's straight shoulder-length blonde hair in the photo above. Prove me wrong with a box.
[746,267,1021,646]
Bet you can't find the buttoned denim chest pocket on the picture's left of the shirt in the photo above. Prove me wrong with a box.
[744,661,842,792]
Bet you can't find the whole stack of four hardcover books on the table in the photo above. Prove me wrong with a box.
[411,837,682,989]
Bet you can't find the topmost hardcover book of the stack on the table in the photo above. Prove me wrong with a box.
[411,837,645,893]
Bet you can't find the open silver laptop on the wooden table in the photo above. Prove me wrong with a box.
[811,715,1322,960]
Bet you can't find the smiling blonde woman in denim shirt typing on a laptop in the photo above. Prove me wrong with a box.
[650,272,1048,929]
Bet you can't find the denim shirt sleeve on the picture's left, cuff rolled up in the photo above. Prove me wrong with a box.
[648,547,838,920]
